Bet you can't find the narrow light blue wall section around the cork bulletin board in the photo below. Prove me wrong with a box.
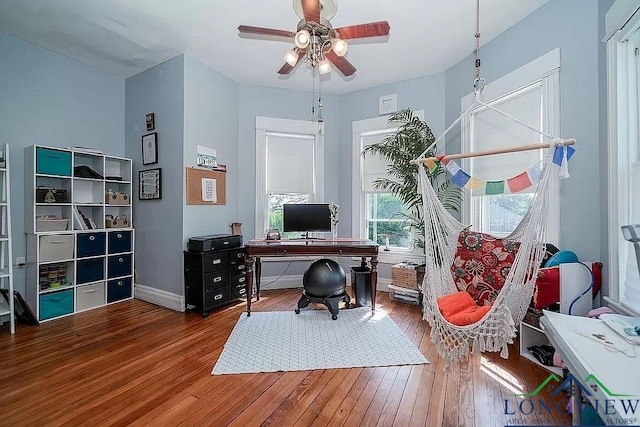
[183,55,241,241]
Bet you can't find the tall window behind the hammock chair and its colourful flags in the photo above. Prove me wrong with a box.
[462,50,560,245]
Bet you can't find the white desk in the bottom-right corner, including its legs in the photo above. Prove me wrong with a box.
[540,311,640,426]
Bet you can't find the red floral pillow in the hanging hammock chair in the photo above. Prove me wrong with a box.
[451,229,520,306]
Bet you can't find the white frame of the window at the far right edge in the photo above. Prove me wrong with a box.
[603,0,640,316]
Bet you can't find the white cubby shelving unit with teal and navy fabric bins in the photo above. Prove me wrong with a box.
[25,145,134,321]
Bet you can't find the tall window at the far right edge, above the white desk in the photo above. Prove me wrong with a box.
[605,1,640,315]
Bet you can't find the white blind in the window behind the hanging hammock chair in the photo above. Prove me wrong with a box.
[470,82,542,192]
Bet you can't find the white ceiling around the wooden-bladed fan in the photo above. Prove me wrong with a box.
[0,0,548,94]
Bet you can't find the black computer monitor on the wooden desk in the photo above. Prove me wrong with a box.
[282,203,331,236]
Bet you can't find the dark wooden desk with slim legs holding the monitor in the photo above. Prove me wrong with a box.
[244,239,378,317]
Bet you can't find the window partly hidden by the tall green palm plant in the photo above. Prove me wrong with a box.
[352,110,424,261]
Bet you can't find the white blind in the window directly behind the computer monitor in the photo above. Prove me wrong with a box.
[267,133,314,194]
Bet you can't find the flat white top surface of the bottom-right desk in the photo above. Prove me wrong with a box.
[543,310,640,396]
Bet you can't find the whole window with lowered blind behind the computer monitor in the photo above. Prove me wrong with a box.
[255,117,324,237]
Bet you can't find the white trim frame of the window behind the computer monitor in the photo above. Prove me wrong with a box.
[255,116,324,238]
